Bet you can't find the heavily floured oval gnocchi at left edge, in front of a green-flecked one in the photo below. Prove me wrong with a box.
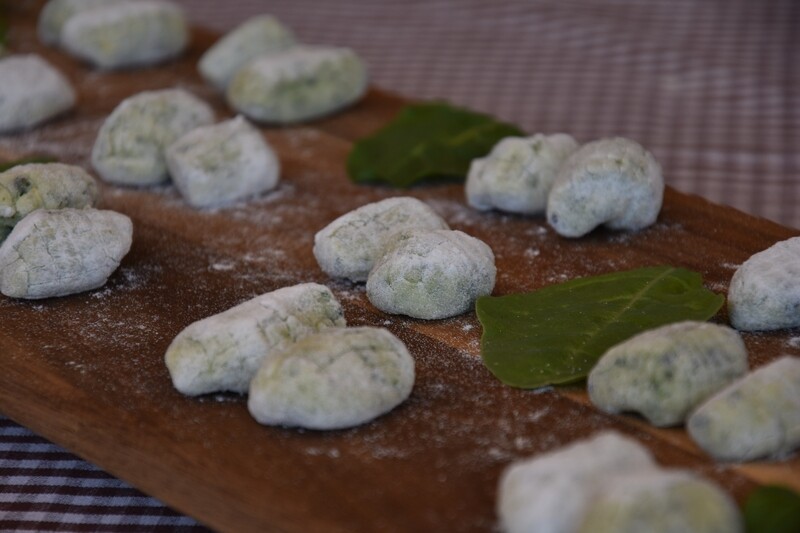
[0,208,133,299]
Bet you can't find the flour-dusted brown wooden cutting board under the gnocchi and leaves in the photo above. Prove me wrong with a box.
[0,3,800,532]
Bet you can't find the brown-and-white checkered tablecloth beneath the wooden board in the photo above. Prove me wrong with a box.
[0,0,800,532]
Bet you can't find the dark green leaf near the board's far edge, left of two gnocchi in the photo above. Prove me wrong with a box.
[347,102,523,187]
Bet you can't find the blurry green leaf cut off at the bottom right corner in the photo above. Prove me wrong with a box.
[744,485,800,533]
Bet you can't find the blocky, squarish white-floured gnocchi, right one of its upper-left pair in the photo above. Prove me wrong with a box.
[166,117,280,207]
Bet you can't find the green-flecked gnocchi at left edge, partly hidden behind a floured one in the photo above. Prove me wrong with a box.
[0,163,99,233]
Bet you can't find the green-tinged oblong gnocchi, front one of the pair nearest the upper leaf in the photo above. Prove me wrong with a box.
[226,45,367,124]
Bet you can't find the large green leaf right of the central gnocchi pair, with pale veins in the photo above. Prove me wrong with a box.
[476,266,725,388]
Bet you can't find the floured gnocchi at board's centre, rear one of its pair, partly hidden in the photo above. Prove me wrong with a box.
[314,196,448,281]
